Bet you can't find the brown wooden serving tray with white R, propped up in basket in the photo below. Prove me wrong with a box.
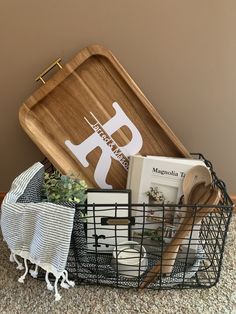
[19,45,190,189]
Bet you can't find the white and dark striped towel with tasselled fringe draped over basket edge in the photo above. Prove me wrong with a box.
[1,162,75,300]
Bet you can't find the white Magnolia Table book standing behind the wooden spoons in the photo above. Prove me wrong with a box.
[127,155,206,253]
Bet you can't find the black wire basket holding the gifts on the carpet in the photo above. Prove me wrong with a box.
[43,154,233,289]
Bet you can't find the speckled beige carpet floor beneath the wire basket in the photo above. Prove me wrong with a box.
[0,217,236,314]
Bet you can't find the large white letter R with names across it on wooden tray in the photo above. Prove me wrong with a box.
[65,102,143,188]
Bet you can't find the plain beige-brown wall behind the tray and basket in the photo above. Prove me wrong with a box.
[0,0,236,193]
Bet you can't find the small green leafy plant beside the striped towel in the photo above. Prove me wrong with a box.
[42,170,87,203]
